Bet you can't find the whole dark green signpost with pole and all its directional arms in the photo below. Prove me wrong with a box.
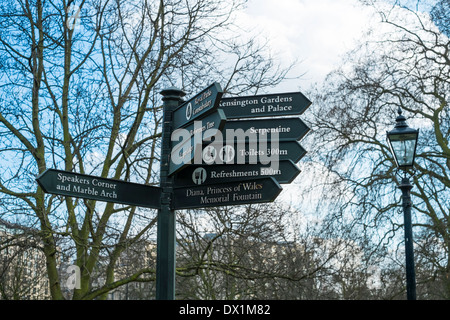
[36,83,311,300]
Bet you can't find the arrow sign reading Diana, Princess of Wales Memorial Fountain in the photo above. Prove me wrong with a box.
[173,178,282,209]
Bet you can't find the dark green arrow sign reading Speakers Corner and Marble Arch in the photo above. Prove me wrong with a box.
[36,169,161,209]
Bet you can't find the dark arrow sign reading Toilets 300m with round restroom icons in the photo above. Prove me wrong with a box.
[202,141,306,165]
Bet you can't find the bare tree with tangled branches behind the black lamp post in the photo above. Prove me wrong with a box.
[311,1,450,299]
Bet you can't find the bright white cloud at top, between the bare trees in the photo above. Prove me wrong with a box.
[238,0,378,90]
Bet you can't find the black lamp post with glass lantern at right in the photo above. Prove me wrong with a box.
[387,108,419,300]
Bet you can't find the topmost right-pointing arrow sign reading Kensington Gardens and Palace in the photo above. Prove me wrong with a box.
[220,92,311,119]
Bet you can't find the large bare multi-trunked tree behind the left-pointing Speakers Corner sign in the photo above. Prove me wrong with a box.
[0,0,296,299]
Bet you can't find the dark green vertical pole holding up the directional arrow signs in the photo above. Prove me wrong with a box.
[156,87,185,300]
